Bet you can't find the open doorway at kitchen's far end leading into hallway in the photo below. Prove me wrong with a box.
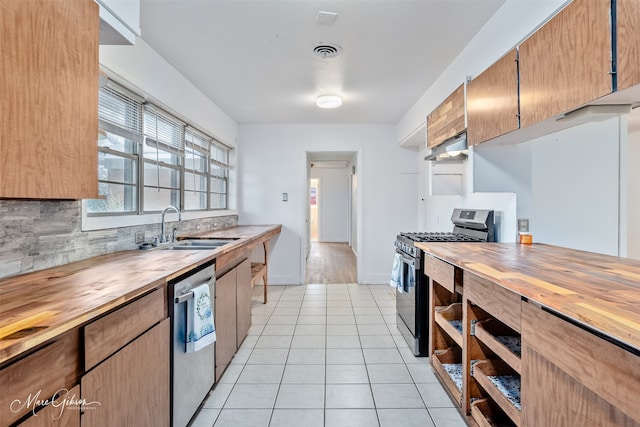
[305,152,358,283]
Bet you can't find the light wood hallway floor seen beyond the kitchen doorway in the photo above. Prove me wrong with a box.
[305,242,357,283]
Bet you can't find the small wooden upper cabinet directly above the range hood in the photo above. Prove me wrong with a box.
[427,84,466,148]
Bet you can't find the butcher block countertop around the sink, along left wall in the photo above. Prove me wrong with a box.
[0,225,281,365]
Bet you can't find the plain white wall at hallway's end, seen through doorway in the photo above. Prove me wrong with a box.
[311,167,351,243]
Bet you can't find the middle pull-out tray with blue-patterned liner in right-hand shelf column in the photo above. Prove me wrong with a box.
[472,360,522,426]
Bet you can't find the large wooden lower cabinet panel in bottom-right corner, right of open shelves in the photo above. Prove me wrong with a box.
[522,303,640,427]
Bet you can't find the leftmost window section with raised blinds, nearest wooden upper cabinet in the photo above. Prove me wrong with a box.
[87,83,142,214]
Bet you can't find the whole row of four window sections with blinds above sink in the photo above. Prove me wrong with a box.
[88,81,229,216]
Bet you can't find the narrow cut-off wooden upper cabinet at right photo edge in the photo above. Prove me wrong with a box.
[616,0,640,90]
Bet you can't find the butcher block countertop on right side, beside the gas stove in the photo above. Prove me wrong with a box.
[416,243,640,350]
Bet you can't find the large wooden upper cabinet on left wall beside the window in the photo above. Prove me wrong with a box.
[0,0,99,199]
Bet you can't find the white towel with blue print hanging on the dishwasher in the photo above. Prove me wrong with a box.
[186,284,216,353]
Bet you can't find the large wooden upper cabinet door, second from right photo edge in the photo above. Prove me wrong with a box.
[519,0,612,128]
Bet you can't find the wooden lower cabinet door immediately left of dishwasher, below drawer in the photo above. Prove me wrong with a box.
[80,319,170,427]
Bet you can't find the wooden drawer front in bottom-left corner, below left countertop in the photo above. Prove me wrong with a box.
[0,339,70,426]
